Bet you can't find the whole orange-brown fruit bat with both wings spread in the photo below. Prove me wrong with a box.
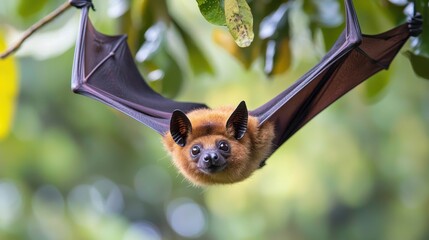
[71,0,422,185]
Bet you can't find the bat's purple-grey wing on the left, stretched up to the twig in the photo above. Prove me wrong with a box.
[72,6,207,135]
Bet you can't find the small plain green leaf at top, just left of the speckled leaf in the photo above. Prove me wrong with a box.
[197,0,226,26]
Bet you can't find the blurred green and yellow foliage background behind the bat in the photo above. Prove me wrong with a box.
[0,0,429,240]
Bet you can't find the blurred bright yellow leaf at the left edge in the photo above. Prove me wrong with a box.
[0,32,18,140]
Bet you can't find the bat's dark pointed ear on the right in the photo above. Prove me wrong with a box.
[226,101,249,140]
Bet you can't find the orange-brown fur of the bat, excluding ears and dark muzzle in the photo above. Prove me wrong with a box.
[163,107,274,185]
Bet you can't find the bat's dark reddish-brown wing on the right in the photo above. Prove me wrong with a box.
[249,0,421,152]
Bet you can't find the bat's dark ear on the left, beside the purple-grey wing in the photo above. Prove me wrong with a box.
[170,110,192,147]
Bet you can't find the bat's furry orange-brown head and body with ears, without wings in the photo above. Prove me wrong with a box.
[163,102,274,185]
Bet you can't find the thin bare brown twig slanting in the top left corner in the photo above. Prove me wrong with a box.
[0,1,71,59]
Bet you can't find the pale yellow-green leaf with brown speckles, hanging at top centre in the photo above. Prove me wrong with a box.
[225,0,254,47]
